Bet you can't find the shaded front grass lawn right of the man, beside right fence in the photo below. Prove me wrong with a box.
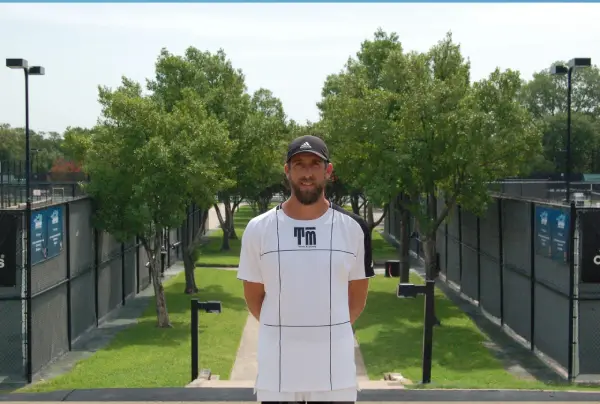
[356,274,592,389]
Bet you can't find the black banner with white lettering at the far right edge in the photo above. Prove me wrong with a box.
[579,211,600,283]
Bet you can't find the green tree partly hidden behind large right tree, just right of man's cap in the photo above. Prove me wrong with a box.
[318,29,402,229]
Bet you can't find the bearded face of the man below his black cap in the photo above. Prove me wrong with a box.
[285,153,332,205]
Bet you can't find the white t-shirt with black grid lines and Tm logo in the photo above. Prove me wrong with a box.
[238,204,374,392]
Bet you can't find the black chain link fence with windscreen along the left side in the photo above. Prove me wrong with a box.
[0,197,202,383]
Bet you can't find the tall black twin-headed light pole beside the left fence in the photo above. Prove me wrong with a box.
[6,59,45,383]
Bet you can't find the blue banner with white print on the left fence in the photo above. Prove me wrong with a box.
[30,206,63,265]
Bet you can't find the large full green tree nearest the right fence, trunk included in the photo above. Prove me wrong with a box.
[394,34,541,278]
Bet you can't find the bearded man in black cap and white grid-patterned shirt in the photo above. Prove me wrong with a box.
[238,136,374,402]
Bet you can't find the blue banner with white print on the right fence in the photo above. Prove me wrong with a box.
[535,206,570,262]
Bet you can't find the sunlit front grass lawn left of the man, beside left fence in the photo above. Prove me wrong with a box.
[20,268,248,392]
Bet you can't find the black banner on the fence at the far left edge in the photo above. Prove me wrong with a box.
[0,212,19,287]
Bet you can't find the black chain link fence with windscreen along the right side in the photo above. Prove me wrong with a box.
[385,193,600,380]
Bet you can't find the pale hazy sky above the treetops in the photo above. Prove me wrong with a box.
[0,3,600,132]
